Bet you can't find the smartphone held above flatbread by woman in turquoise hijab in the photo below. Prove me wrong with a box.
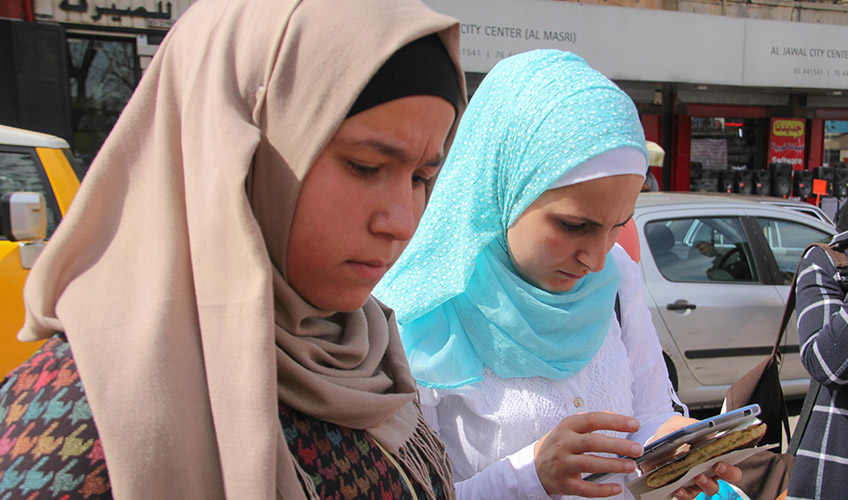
[583,404,760,483]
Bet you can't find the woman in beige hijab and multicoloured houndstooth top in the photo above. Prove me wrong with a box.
[0,0,465,500]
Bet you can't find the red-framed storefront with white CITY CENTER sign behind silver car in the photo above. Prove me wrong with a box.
[425,0,848,199]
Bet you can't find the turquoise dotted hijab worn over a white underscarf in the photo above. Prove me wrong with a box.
[374,50,647,388]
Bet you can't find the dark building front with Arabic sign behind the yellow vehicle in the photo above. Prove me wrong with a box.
[0,0,194,168]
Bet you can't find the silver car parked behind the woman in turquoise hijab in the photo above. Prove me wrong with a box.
[633,193,835,408]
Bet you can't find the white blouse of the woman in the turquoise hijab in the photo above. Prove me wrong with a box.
[419,245,676,500]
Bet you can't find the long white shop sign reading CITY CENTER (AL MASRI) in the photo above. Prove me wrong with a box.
[424,0,848,89]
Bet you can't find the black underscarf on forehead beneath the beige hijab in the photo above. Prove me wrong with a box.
[347,35,459,116]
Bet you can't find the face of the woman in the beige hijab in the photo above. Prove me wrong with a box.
[286,96,455,311]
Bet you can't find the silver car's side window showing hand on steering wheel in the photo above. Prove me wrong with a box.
[643,217,759,283]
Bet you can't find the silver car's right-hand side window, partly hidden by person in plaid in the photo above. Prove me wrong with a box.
[757,217,831,285]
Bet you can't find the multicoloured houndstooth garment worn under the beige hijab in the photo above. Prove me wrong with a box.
[0,334,444,500]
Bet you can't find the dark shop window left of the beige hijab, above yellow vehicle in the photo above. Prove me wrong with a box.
[68,34,141,165]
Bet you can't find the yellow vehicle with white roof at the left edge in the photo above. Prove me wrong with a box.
[0,125,84,379]
